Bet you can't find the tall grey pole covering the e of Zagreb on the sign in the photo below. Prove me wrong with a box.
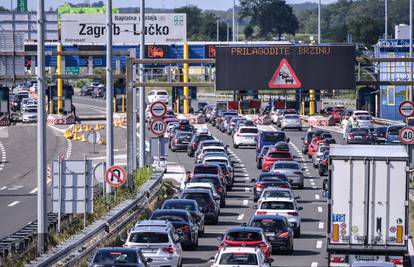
[106,0,114,187]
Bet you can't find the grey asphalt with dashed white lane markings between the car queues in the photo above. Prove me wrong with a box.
[169,122,342,267]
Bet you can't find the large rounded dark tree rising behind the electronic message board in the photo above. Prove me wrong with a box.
[240,0,299,40]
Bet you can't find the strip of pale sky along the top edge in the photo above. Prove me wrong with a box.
[21,0,336,10]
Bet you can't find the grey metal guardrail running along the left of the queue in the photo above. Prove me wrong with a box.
[26,171,164,266]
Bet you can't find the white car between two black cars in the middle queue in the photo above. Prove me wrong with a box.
[255,197,303,237]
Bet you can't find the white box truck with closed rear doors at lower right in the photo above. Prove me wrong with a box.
[326,145,409,266]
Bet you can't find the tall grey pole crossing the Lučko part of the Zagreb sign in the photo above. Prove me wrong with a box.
[139,0,145,168]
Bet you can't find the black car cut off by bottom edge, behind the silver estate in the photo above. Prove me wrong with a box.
[89,247,152,267]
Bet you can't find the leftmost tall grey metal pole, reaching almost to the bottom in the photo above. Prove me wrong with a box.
[37,0,48,255]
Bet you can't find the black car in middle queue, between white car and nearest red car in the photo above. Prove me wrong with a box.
[248,215,294,254]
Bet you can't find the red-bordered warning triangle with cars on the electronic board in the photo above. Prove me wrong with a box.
[268,58,302,88]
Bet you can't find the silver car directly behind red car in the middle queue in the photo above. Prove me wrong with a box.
[269,161,304,189]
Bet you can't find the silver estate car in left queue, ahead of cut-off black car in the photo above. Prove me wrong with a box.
[123,220,183,267]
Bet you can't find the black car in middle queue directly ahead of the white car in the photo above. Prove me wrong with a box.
[251,172,290,202]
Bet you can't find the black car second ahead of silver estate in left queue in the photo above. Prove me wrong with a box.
[161,199,204,235]
